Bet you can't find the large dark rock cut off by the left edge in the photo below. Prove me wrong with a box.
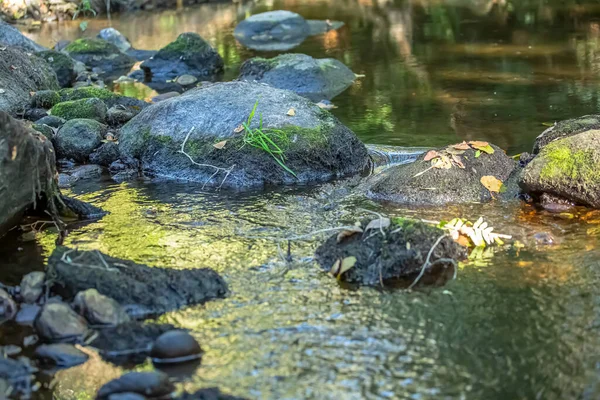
[0,111,59,236]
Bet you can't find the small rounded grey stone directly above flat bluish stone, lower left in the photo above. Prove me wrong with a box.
[35,302,88,342]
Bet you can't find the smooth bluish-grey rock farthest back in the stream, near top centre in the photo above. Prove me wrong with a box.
[233,10,310,51]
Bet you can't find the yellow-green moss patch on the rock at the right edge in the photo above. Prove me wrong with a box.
[540,141,600,184]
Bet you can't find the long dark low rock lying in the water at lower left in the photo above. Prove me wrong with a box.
[48,247,227,315]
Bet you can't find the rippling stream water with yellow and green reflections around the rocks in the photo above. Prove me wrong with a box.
[7,0,600,400]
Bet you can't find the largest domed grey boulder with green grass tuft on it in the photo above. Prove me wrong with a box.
[119,81,368,188]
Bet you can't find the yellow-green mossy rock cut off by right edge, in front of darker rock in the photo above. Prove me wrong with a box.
[521,130,600,208]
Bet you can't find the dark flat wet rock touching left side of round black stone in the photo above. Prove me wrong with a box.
[91,321,174,365]
